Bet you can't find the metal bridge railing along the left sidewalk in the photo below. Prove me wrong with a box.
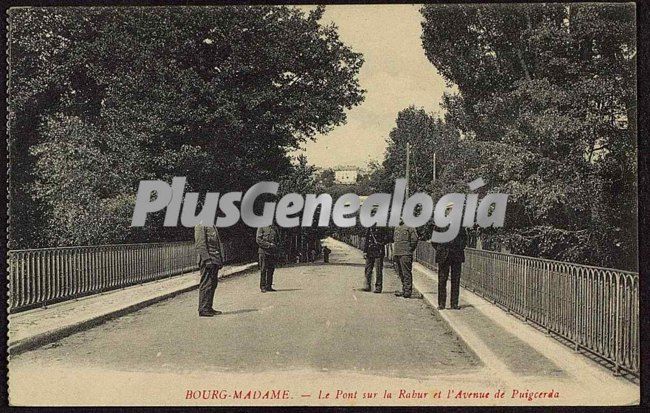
[7,241,239,313]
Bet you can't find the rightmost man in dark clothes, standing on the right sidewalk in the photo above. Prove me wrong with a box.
[433,228,467,310]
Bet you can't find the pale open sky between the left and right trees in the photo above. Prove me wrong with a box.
[295,4,447,168]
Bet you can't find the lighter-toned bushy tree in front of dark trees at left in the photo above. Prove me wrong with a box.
[31,117,144,245]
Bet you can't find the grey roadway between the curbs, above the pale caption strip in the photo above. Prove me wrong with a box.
[12,238,480,377]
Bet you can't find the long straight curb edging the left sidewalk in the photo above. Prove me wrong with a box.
[7,263,257,356]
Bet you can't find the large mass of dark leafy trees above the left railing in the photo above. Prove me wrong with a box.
[9,6,363,248]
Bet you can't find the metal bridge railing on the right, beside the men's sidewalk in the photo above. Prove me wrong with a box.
[343,235,640,375]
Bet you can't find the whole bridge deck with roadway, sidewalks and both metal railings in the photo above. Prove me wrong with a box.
[8,236,640,405]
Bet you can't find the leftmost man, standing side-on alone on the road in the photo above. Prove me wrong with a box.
[194,225,223,317]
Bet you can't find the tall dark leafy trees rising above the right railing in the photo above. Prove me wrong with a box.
[422,3,637,268]
